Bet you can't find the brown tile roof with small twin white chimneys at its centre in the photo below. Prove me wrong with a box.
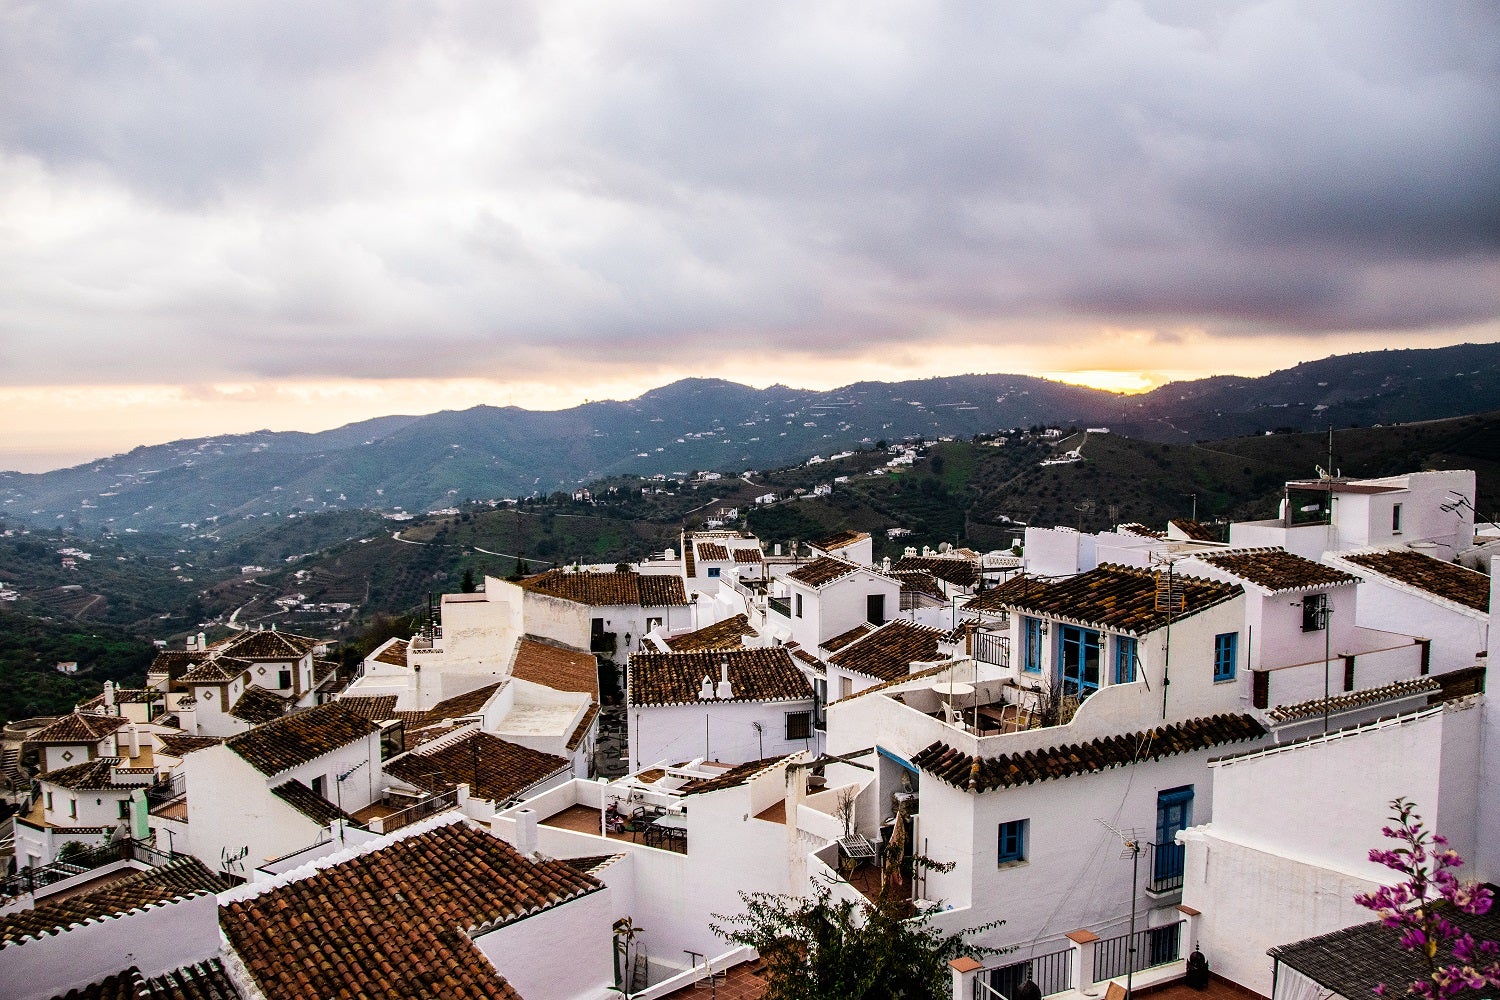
[626,648,813,705]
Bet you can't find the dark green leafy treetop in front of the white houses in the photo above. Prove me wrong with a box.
[710,886,1004,1000]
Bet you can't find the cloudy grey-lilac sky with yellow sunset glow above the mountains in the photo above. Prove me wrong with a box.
[0,0,1500,471]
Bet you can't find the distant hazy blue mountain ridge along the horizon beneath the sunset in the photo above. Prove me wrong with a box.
[0,343,1500,531]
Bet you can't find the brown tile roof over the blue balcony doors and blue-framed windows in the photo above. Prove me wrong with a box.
[1008,564,1244,636]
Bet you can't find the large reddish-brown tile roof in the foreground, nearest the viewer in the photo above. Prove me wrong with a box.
[219,822,603,1000]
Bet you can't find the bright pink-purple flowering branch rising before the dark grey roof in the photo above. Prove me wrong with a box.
[1355,798,1500,1000]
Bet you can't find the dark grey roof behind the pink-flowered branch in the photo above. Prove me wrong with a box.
[1266,886,1500,1000]
